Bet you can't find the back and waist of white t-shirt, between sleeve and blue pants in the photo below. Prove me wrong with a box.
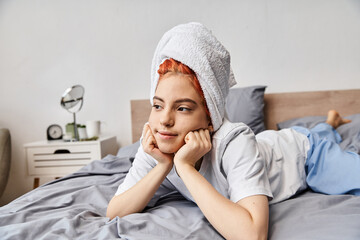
[256,128,310,204]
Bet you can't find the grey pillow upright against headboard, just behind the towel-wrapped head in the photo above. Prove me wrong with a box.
[225,86,266,134]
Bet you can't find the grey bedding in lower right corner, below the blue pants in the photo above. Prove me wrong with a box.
[268,190,360,240]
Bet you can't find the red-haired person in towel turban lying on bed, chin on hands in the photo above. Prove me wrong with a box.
[107,23,360,239]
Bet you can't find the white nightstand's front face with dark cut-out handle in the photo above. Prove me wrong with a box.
[27,145,101,175]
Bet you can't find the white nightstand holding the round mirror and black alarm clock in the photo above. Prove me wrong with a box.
[24,137,117,188]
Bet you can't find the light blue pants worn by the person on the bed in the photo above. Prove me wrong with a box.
[293,123,360,196]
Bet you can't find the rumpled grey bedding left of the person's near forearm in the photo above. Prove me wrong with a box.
[0,155,223,240]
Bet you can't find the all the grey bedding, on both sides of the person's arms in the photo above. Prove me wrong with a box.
[0,144,360,240]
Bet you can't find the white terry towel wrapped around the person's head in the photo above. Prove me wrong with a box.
[150,22,236,131]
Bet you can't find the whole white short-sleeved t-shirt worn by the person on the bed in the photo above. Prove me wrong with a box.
[115,119,307,206]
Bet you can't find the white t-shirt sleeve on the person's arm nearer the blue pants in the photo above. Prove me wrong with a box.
[222,128,272,202]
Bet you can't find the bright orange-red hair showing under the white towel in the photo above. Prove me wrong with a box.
[158,58,211,119]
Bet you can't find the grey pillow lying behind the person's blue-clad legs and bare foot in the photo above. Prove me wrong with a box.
[277,113,360,154]
